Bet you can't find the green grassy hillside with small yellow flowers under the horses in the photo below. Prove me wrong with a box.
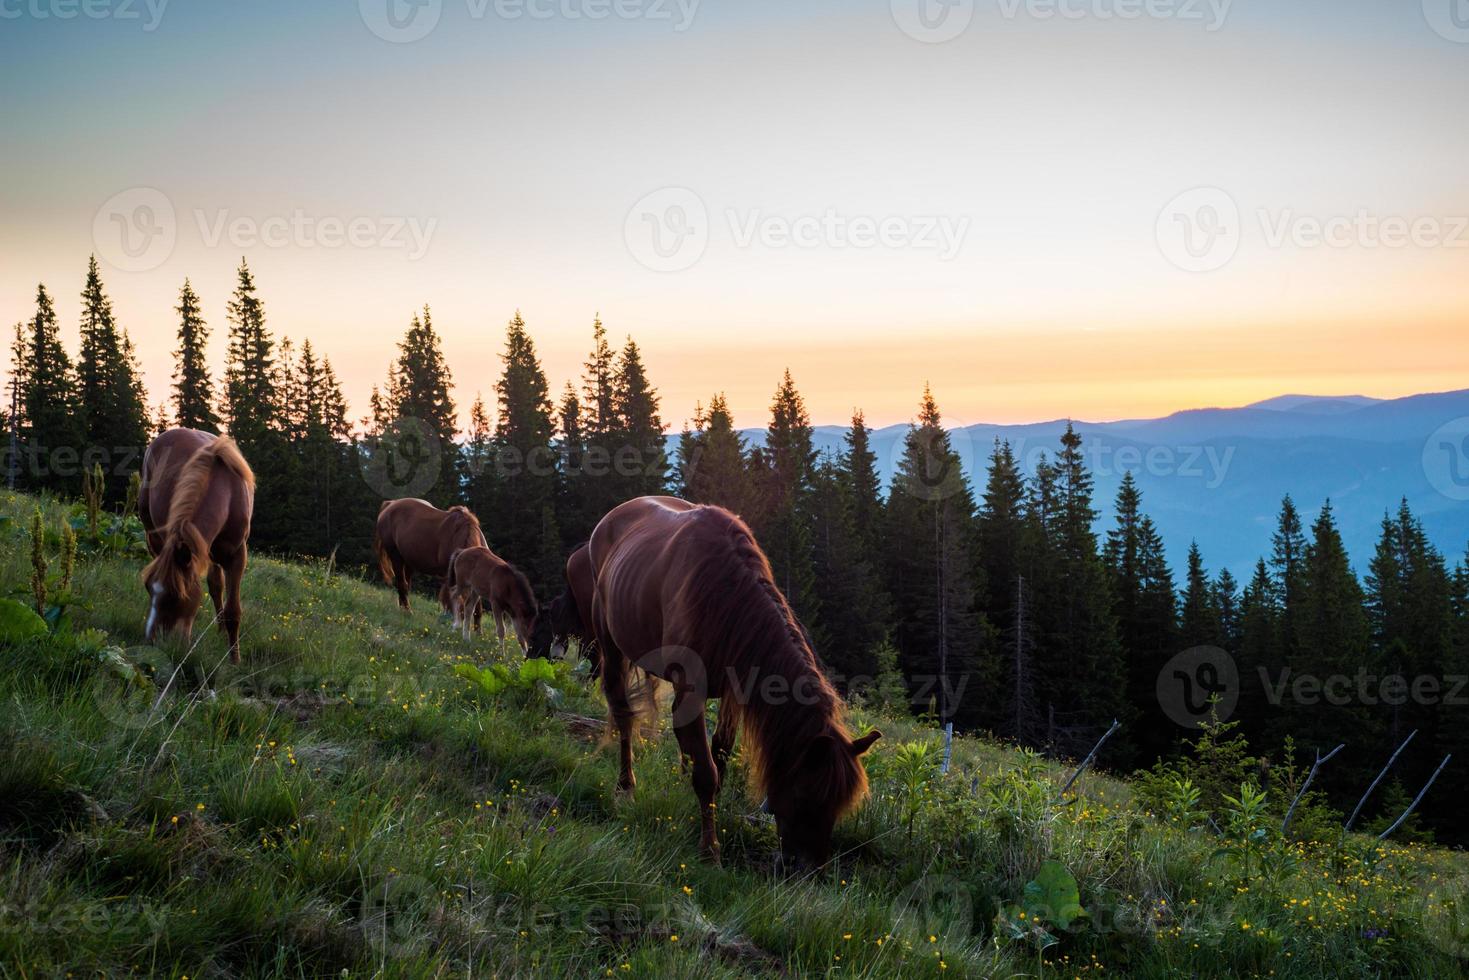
[0,494,1469,979]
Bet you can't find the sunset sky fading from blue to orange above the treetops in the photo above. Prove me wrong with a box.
[0,0,1469,429]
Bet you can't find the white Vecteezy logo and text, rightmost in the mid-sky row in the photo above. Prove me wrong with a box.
[1155,189,1469,272]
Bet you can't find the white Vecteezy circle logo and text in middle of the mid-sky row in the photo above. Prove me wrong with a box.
[623,187,970,272]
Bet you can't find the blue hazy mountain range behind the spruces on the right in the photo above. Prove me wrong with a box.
[731,389,1469,579]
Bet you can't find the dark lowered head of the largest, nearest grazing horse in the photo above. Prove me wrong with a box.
[768,726,883,871]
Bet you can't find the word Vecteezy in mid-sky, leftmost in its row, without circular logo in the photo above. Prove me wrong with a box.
[194,207,428,262]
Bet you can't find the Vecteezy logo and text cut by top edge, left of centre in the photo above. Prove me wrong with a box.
[357,0,701,44]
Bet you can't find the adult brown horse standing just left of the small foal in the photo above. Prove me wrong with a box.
[372,498,488,626]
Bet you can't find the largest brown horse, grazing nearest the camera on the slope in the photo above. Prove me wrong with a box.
[589,497,880,867]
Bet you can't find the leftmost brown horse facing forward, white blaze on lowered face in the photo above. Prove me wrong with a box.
[138,429,256,664]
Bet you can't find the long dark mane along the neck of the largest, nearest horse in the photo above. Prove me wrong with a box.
[683,507,867,817]
